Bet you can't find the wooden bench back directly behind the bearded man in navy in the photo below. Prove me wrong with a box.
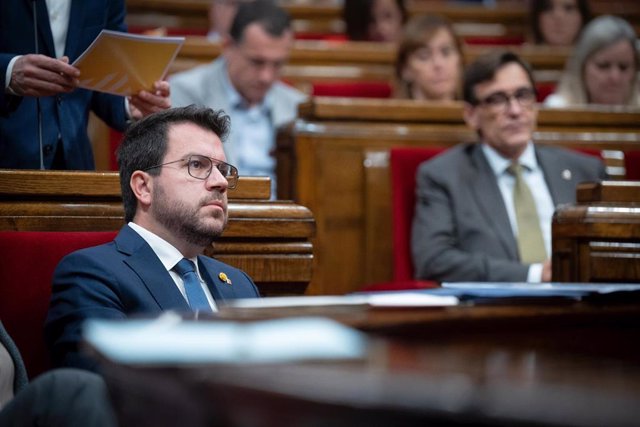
[0,169,315,295]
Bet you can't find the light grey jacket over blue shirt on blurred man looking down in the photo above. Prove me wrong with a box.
[169,57,306,168]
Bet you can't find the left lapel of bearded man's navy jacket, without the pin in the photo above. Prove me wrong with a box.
[115,226,191,311]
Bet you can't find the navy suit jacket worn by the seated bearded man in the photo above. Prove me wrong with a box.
[45,226,259,369]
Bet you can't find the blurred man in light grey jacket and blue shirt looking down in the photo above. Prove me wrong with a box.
[170,0,306,197]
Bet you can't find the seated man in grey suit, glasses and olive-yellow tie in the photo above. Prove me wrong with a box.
[411,51,606,282]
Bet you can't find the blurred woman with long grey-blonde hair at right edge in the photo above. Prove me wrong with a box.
[545,15,640,107]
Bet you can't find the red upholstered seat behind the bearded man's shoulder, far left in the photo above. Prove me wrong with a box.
[0,231,117,378]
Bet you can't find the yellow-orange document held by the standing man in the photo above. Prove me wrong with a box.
[73,30,184,96]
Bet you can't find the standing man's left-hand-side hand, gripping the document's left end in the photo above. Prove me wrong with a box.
[9,54,80,96]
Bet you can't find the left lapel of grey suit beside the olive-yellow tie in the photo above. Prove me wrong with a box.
[468,143,518,259]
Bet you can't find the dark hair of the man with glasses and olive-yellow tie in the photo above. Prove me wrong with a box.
[462,50,536,105]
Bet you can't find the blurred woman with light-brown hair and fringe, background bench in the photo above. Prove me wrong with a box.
[395,15,463,101]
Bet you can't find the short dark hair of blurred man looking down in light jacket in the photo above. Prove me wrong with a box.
[229,0,291,43]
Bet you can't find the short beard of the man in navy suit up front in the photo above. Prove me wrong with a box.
[151,186,228,248]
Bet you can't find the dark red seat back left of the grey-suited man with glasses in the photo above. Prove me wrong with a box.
[389,147,445,283]
